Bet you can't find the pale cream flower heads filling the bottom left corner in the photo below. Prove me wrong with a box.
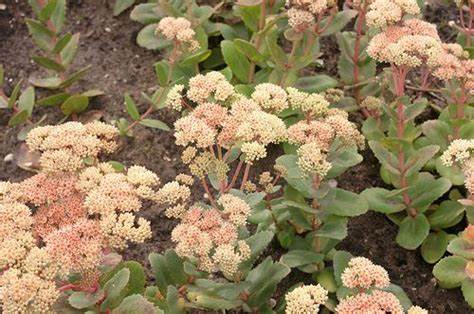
[0,202,60,313]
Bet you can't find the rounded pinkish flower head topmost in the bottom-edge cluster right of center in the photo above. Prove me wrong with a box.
[341,257,390,289]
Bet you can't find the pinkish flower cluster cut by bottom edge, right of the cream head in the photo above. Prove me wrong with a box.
[335,257,427,314]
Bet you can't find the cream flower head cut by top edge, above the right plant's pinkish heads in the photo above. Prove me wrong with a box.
[366,0,420,27]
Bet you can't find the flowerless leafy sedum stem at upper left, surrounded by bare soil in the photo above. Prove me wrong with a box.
[26,0,103,122]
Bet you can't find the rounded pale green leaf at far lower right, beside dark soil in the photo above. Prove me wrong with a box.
[433,256,467,289]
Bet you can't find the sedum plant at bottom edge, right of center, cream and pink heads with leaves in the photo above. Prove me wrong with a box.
[285,255,428,314]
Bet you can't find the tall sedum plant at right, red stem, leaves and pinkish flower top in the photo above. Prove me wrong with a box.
[363,1,470,263]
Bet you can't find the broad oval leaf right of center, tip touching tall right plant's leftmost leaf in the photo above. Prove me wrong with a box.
[319,188,369,217]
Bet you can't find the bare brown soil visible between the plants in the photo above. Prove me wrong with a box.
[0,0,472,313]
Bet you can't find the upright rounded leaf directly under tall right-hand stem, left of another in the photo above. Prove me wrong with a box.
[396,214,430,250]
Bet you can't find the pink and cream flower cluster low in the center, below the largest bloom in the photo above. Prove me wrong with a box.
[171,194,251,280]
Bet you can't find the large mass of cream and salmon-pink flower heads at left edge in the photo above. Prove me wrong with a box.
[0,122,159,313]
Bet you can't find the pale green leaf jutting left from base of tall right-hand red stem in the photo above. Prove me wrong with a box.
[361,188,406,214]
